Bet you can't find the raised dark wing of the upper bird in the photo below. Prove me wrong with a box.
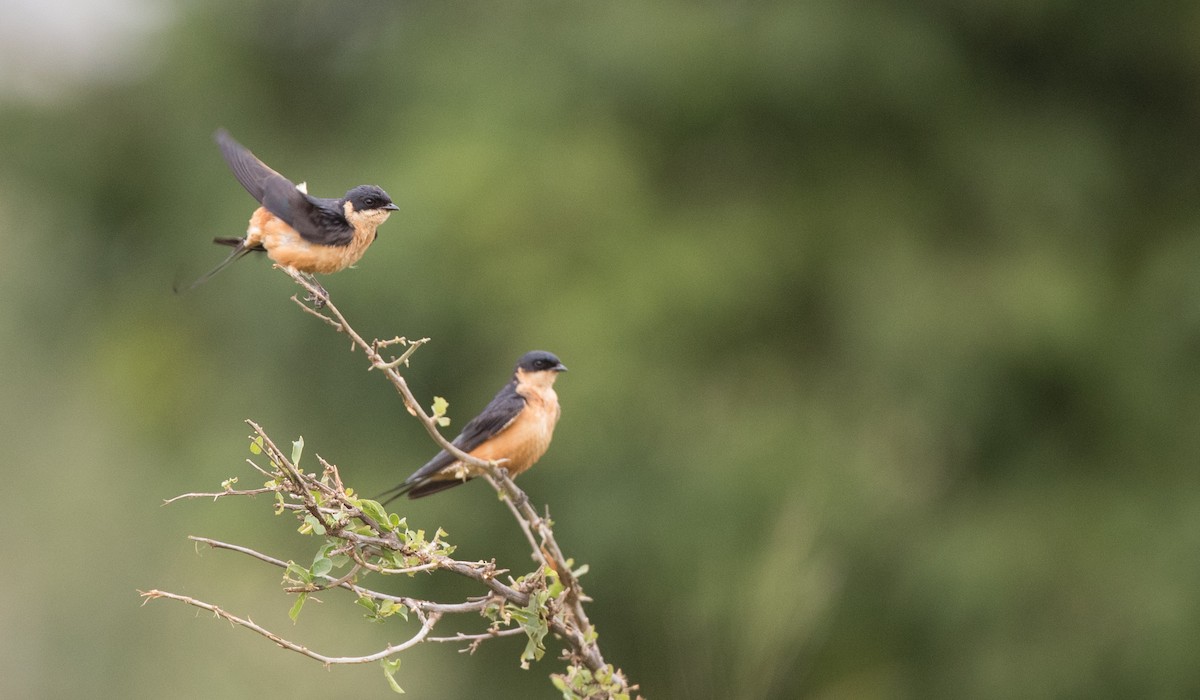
[215,128,354,245]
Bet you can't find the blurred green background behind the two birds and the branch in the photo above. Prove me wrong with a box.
[0,0,1200,699]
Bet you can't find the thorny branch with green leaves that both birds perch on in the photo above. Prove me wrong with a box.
[142,270,637,699]
